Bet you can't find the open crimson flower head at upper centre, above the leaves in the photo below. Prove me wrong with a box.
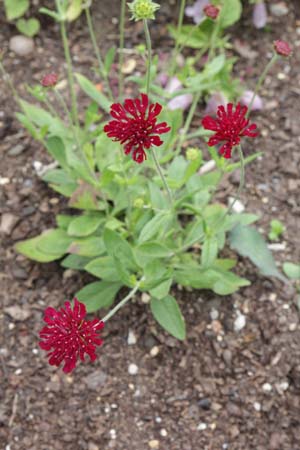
[104,94,171,164]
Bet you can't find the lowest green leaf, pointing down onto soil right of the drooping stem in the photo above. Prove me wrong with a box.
[150,295,186,340]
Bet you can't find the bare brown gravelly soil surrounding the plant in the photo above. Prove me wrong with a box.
[0,0,300,450]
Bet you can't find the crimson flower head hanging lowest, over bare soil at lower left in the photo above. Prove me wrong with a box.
[39,298,104,373]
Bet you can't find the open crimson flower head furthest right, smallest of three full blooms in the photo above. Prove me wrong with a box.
[202,103,258,158]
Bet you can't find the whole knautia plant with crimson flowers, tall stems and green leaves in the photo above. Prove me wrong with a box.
[0,0,291,372]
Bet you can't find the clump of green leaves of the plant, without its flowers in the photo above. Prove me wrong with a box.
[8,2,283,339]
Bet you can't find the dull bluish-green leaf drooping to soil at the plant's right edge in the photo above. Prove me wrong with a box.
[229,225,286,281]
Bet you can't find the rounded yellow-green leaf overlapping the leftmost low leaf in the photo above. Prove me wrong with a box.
[37,228,72,255]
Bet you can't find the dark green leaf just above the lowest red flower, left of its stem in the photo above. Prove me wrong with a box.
[75,281,121,312]
